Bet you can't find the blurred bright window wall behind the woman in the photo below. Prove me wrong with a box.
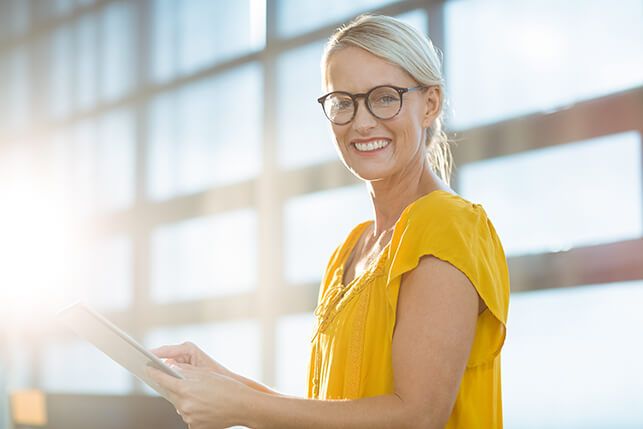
[0,0,643,429]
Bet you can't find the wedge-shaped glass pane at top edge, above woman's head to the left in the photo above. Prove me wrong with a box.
[276,0,396,37]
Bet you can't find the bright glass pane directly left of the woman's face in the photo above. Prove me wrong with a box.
[275,42,337,168]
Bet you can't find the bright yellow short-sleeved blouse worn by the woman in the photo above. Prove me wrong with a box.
[308,190,509,429]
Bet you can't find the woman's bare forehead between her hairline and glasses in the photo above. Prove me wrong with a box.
[322,46,413,92]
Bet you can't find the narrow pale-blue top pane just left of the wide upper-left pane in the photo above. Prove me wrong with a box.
[100,2,136,101]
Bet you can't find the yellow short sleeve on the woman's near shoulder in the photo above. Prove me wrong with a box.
[387,193,509,366]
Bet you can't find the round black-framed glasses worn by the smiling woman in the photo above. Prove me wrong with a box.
[317,85,426,125]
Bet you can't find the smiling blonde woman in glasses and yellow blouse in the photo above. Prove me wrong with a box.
[152,15,509,429]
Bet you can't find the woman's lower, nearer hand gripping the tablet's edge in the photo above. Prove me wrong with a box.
[147,363,256,429]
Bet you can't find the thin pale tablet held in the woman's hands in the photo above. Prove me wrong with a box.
[57,302,183,396]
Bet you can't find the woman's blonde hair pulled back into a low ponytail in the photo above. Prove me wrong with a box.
[321,14,453,184]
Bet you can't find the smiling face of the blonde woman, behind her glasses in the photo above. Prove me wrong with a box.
[326,47,440,181]
